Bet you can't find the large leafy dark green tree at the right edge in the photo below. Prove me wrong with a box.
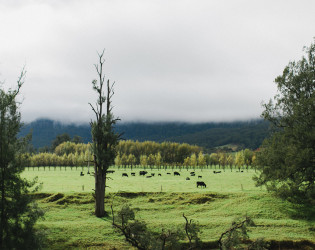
[256,39,315,202]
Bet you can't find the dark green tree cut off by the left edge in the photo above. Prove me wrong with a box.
[0,71,42,249]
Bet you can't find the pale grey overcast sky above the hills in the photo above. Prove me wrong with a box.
[0,0,315,123]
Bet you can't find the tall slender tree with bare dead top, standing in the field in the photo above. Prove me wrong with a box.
[89,50,121,217]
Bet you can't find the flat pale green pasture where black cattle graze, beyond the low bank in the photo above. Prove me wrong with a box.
[22,167,264,193]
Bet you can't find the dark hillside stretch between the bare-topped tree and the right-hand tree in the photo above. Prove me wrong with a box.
[117,120,269,149]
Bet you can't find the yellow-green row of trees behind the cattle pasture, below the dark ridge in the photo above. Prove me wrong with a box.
[24,140,256,170]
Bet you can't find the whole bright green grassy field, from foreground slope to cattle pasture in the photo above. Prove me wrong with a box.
[23,168,315,249]
